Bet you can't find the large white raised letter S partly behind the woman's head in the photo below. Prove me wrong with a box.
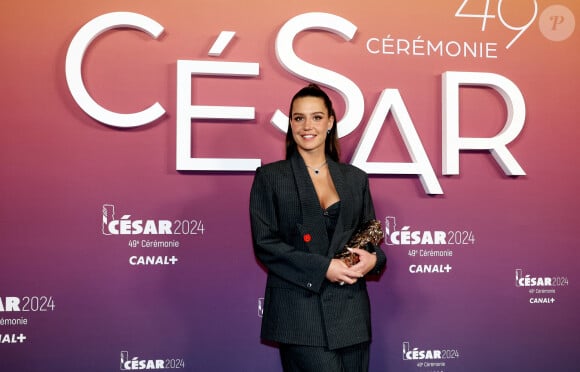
[270,12,364,137]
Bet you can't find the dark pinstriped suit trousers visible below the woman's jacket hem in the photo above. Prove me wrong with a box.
[280,342,370,372]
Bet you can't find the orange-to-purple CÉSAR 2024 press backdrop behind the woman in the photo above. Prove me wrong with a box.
[0,0,580,371]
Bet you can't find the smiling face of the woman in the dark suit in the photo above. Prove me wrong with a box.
[290,97,334,153]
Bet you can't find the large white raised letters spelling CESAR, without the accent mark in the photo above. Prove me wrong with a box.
[66,12,526,194]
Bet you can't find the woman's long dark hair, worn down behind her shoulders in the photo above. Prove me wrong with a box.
[286,84,340,161]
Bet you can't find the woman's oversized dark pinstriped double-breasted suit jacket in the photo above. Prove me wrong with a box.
[250,153,386,349]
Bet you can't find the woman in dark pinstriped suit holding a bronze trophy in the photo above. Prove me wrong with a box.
[250,84,386,372]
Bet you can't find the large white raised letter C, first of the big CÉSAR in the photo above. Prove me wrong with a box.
[65,12,165,128]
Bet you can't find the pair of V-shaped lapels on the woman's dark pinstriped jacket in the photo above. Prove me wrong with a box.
[291,152,352,257]
